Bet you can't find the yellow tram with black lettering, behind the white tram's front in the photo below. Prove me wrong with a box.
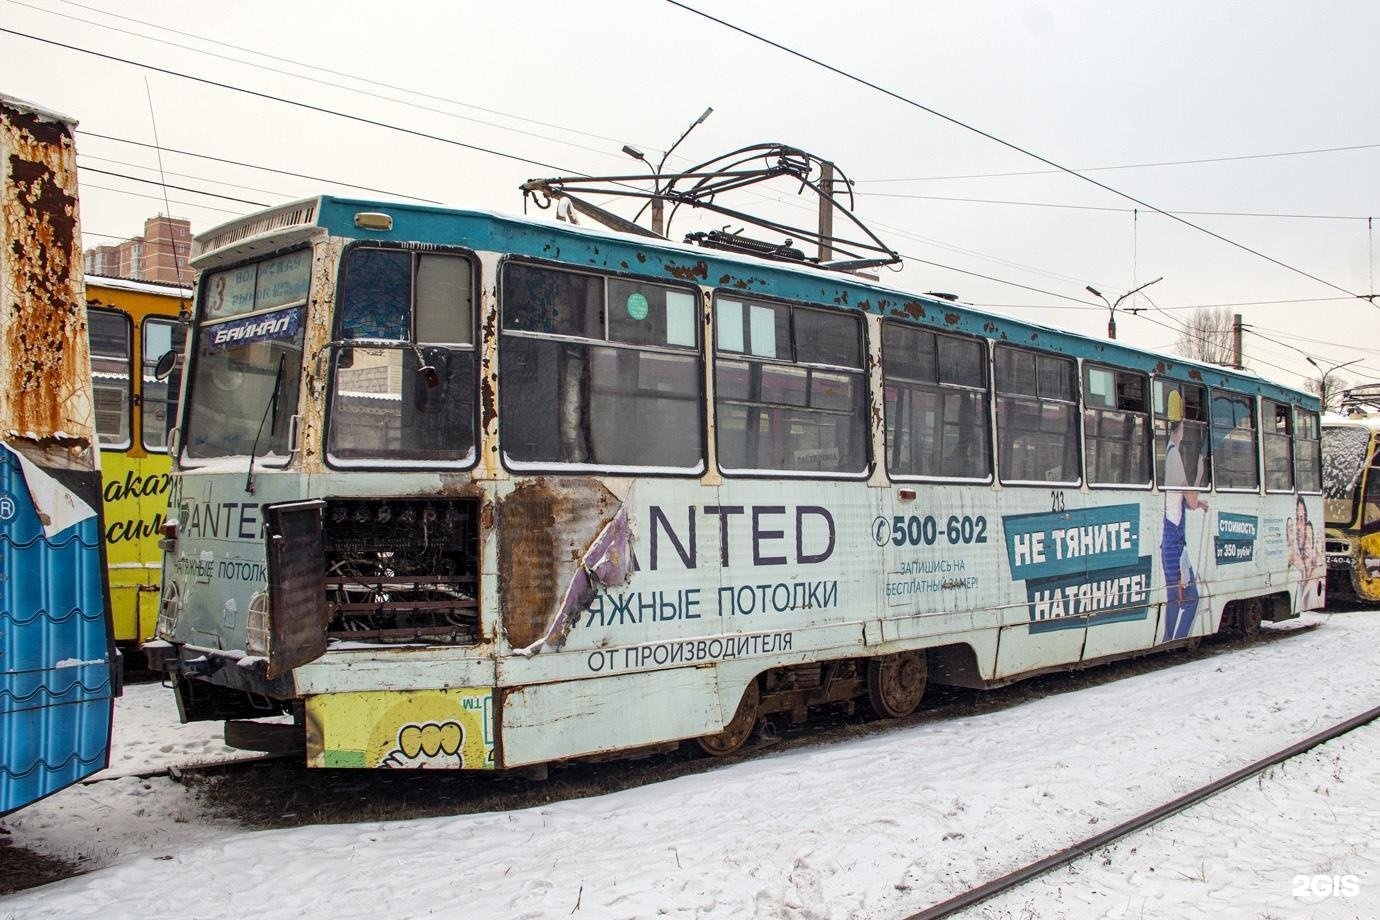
[86,276,192,666]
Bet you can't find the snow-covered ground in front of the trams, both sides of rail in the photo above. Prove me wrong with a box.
[0,612,1380,920]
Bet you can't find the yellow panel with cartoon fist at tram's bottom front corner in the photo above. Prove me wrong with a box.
[306,688,494,770]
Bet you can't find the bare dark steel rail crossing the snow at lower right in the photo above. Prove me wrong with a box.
[905,706,1380,920]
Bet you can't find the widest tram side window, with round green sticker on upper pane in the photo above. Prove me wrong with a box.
[498,263,704,472]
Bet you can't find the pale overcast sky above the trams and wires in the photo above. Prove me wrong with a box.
[0,0,1380,383]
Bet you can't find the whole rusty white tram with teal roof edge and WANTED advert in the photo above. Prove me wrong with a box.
[146,197,1323,770]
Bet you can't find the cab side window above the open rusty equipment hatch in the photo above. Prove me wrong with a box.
[327,248,476,466]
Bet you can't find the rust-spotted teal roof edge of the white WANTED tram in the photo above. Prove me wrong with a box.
[193,196,1318,410]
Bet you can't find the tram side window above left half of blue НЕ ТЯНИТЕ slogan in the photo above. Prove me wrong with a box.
[996,345,1078,484]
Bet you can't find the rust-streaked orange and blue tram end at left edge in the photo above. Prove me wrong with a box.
[0,97,119,814]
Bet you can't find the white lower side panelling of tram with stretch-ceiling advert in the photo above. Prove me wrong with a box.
[501,479,1321,766]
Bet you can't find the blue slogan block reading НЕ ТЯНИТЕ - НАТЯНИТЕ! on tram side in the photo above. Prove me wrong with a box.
[1002,505,1152,633]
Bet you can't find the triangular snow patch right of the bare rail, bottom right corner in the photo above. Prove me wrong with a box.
[962,724,1380,920]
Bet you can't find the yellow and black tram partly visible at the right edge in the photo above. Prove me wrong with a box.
[1322,385,1380,604]
